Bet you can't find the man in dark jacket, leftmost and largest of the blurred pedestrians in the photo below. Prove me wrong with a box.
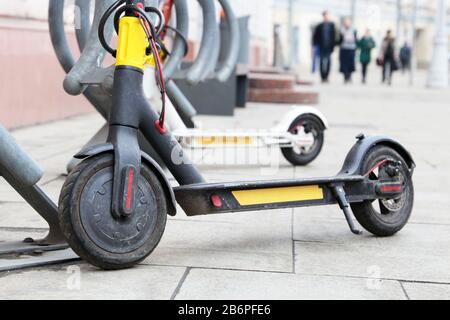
[313,11,336,82]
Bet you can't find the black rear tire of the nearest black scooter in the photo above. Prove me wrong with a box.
[351,146,414,237]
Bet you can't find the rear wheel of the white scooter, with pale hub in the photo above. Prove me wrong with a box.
[281,114,324,166]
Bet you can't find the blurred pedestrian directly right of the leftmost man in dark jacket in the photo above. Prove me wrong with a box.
[339,18,358,83]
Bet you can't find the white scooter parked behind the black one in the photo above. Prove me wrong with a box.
[144,68,328,166]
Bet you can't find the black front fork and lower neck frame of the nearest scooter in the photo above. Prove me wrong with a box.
[108,66,204,217]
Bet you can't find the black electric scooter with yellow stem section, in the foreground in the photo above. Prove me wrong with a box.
[59,0,415,269]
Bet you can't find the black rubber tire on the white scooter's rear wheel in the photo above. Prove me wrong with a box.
[281,114,325,166]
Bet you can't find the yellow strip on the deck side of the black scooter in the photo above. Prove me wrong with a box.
[231,185,324,206]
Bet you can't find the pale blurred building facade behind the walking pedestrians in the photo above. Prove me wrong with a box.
[272,0,444,68]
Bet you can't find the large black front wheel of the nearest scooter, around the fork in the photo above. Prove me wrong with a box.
[59,154,167,270]
